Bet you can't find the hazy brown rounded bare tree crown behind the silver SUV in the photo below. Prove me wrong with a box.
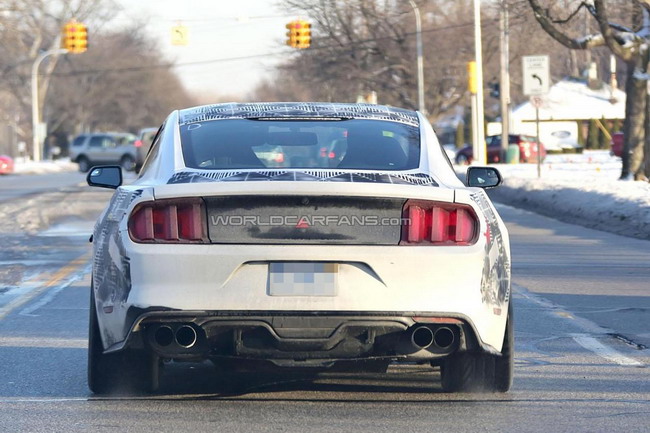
[45,24,193,137]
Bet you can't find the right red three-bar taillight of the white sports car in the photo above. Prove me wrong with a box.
[400,200,479,245]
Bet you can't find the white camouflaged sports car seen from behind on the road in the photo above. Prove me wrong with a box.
[88,103,513,393]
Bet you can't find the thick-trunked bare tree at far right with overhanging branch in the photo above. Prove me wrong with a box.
[528,0,650,180]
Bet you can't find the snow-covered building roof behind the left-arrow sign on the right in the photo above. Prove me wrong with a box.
[512,78,625,122]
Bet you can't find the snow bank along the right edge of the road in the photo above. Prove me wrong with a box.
[480,151,650,239]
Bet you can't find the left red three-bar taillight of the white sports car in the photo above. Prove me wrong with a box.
[129,198,207,243]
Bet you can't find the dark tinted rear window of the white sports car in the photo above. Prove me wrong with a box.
[180,119,420,170]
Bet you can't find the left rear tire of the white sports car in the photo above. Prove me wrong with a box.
[88,289,160,394]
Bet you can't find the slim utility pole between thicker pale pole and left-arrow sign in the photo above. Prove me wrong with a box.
[499,0,510,162]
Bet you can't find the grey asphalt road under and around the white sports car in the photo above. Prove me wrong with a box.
[0,174,650,432]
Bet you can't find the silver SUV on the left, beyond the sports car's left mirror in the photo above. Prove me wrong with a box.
[70,132,137,173]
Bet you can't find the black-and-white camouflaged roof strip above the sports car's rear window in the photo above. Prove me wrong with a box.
[179,102,420,127]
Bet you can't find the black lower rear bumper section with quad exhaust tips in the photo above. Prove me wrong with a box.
[108,311,493,367]
